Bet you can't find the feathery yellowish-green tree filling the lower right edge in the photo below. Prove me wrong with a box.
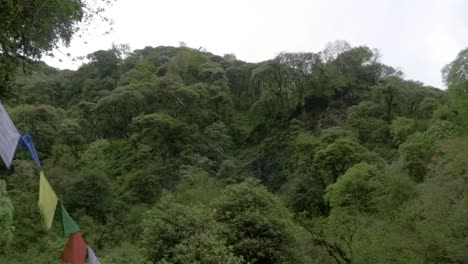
[402,137,468,263]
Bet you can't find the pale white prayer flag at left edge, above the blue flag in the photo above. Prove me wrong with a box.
[0,103,21,168]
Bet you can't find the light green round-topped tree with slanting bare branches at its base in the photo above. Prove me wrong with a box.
[305,162,383,263]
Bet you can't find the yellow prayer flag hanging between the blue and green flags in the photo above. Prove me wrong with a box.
[39,170,58,230]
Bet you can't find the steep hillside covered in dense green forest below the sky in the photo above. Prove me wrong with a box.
[0,41,468,264]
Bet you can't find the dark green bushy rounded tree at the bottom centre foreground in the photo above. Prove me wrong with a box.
[214,179,300,263]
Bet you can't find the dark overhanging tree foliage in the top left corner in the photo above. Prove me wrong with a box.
[0,0,110,97]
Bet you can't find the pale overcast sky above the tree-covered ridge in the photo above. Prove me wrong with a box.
[45,0,468,88]
